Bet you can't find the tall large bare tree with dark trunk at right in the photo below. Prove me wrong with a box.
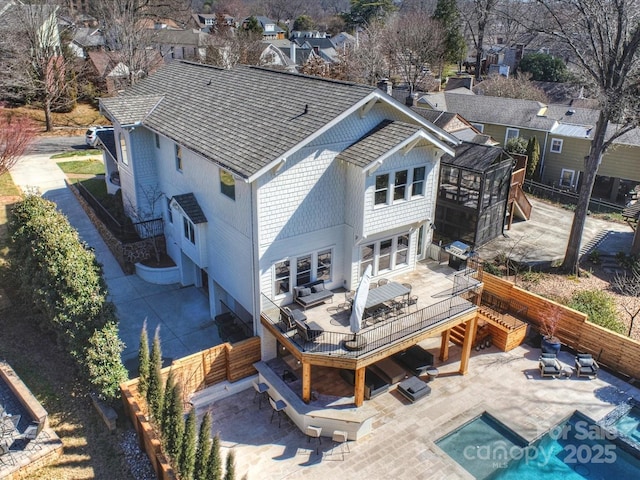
[530,0,640,273]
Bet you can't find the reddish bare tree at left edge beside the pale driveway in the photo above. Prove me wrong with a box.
[0,108,36,175]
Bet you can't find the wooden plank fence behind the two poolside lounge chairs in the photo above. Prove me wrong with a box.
[482,272,640,378]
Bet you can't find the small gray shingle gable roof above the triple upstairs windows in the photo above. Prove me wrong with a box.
[336,120,422,168]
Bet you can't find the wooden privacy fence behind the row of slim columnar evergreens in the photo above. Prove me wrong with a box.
[120,337,260,480]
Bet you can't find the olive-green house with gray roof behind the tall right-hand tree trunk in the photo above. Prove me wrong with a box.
[418,89,640,201]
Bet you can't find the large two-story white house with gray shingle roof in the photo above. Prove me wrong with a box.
[100,61,459,358]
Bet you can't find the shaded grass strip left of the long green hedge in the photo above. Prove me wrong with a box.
[0,175,134,480]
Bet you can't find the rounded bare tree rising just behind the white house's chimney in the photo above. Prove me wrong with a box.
[387,13,445,93]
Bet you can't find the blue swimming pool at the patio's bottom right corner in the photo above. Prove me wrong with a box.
[436,412,640,480]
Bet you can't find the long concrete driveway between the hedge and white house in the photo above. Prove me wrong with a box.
[11,154,216,374]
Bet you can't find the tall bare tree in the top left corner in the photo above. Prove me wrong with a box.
[0,1,74,131]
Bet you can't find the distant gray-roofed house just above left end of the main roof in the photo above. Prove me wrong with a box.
[149,28,211,62]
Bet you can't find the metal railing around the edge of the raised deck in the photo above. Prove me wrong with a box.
[262,294,477,358]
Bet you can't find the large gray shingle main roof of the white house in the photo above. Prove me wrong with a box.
[101,61,376,178]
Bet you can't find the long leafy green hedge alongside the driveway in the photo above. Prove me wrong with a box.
[9,195,127,400]
